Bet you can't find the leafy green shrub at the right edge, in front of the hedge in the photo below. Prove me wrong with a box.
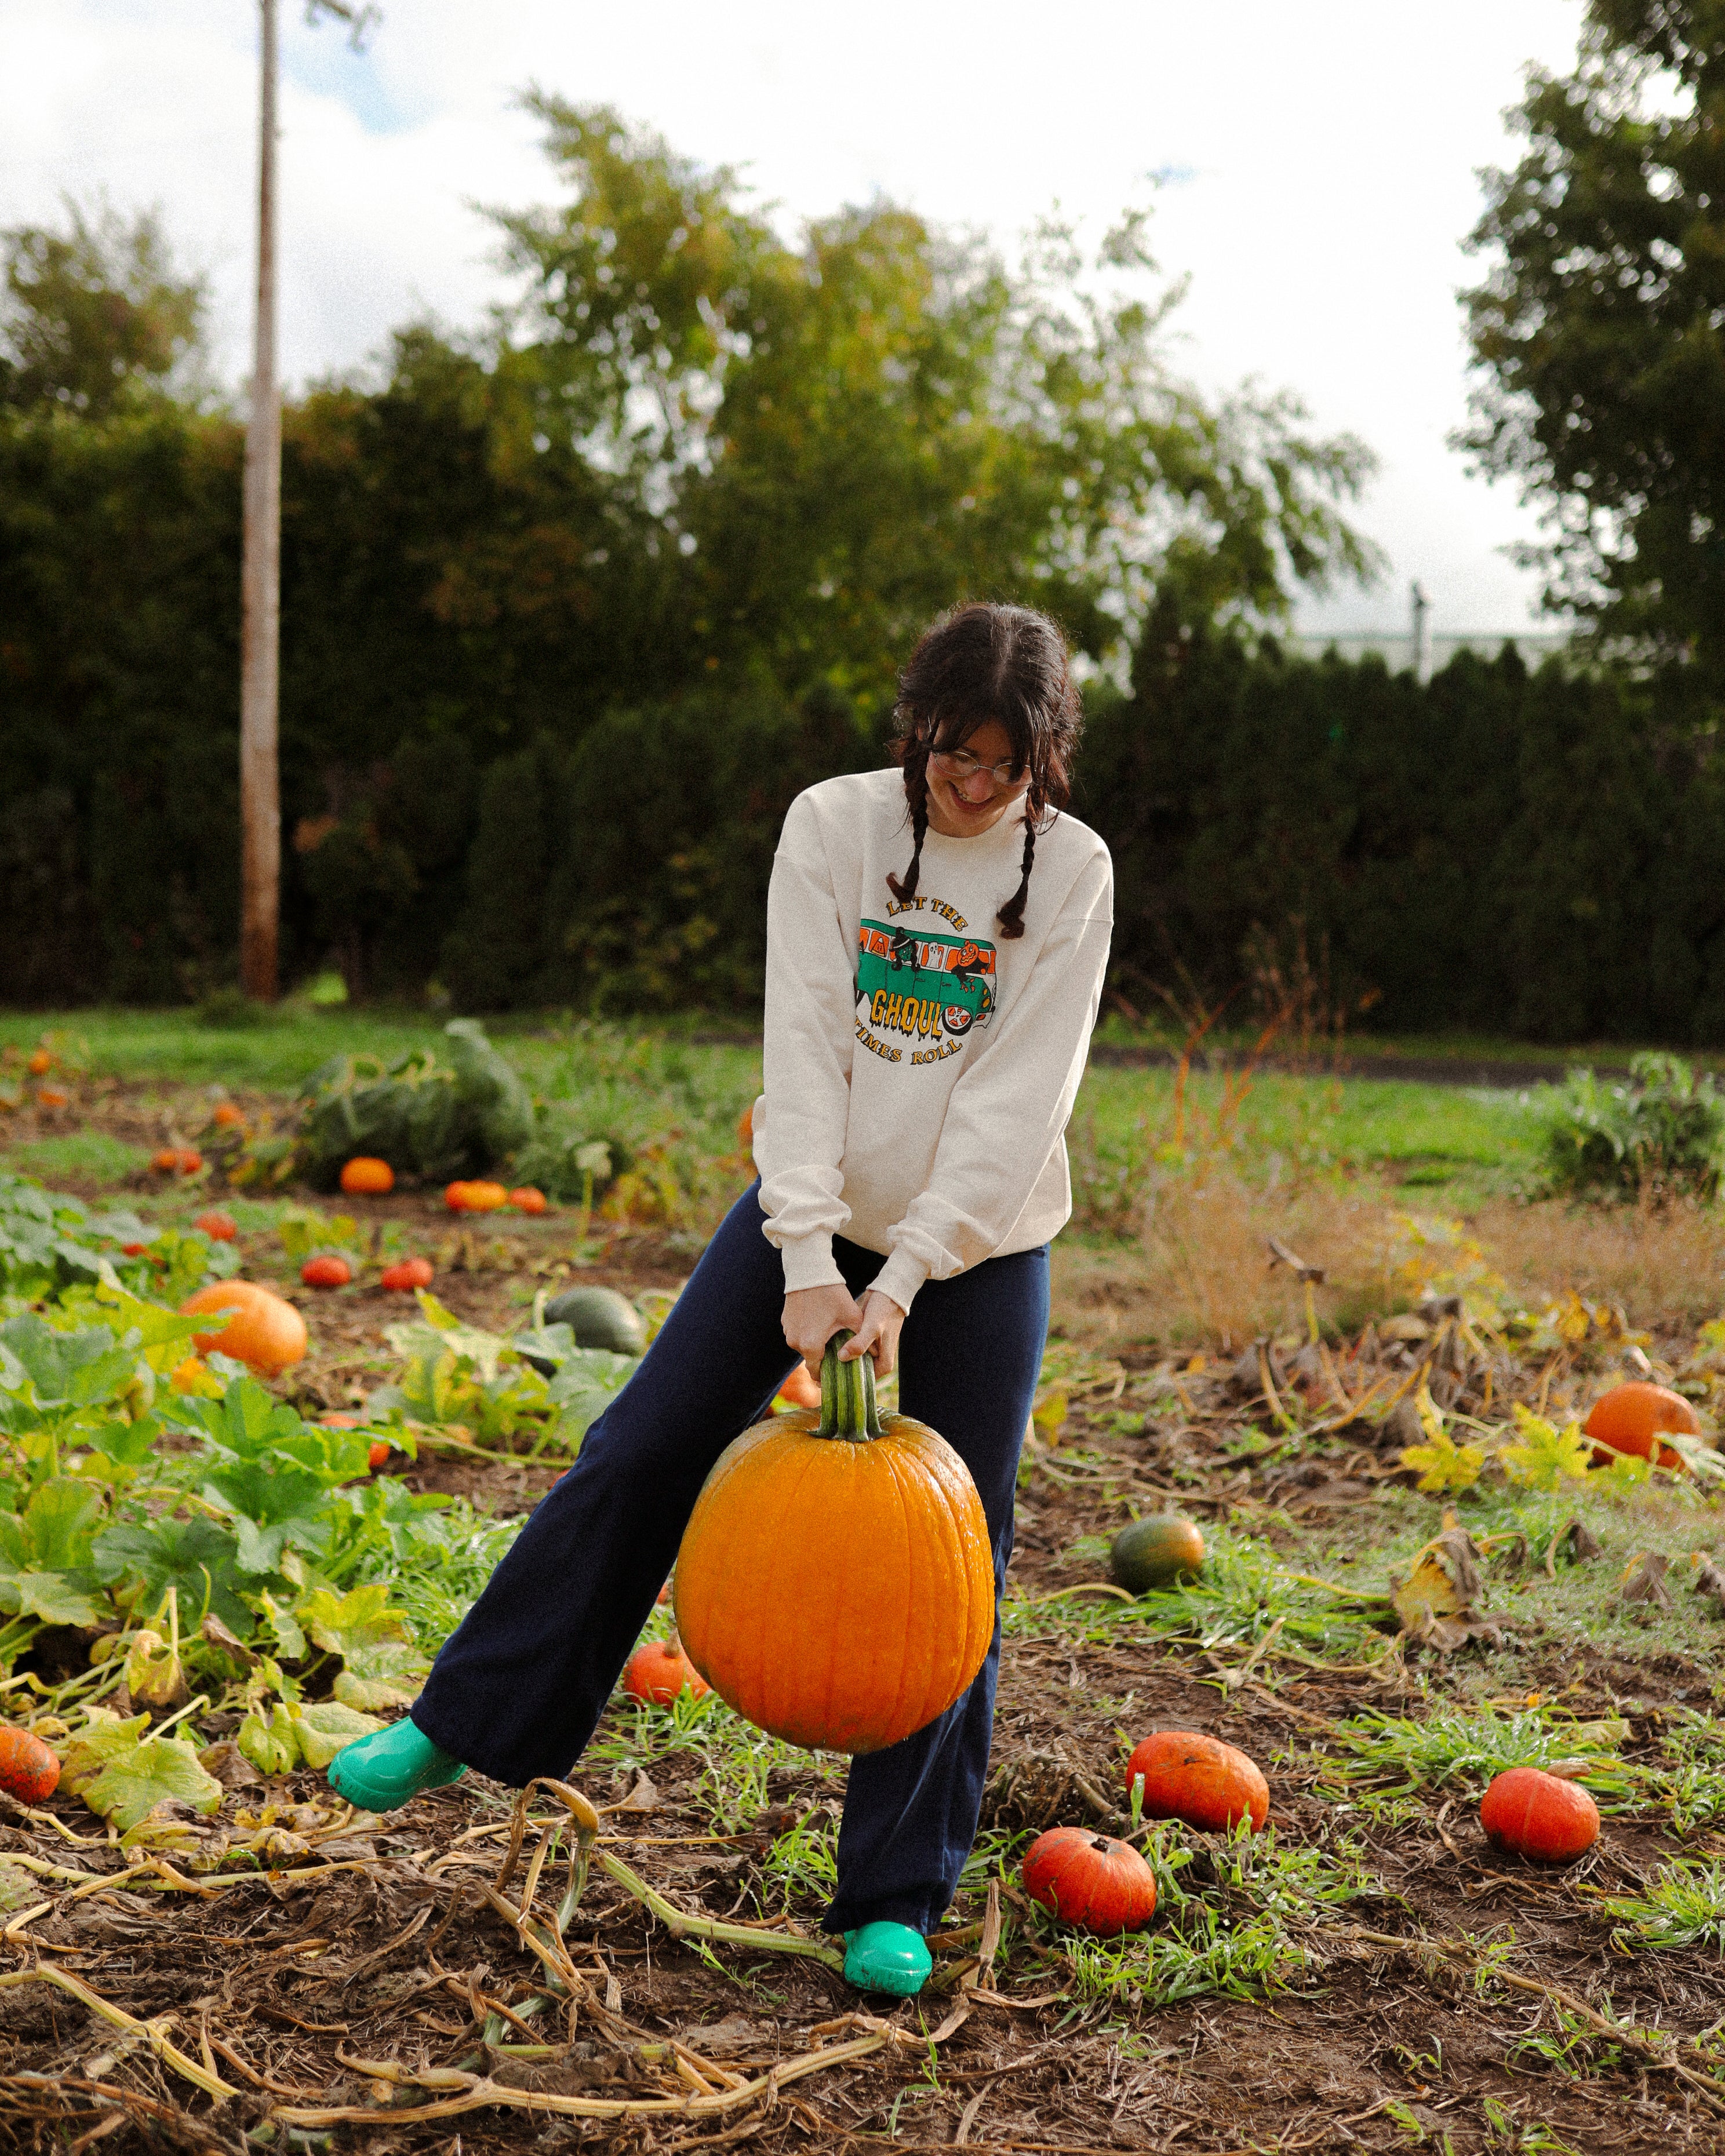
[1546,1054,1725,1199]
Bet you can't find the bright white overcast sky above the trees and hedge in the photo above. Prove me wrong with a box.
[0,0,1581,632]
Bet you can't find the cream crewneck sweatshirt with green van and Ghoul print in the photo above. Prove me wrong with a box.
[755,767,1113,1311]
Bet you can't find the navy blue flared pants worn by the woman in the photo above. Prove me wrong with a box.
[414,1186,1048,1932]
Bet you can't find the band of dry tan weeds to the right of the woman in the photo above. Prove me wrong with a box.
[1054,1175,1725,1350]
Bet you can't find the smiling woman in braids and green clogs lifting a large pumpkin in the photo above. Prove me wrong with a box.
[330,606,1113,1997]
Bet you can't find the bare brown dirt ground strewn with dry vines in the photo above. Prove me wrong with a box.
[0,1095,1725,2156]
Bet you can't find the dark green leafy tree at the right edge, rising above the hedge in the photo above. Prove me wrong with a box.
[1462,0,1725,677]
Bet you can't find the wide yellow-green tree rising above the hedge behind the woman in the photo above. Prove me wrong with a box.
[498,93,1374,701]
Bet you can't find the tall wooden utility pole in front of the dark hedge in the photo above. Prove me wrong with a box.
[239,0,282,1003]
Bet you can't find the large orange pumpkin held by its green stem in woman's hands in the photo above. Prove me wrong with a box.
[673,1332,994,1753]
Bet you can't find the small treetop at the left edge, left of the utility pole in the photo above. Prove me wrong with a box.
[0,198,209,418]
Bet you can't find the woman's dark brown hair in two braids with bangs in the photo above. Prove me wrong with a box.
[886,599,1082,940]
